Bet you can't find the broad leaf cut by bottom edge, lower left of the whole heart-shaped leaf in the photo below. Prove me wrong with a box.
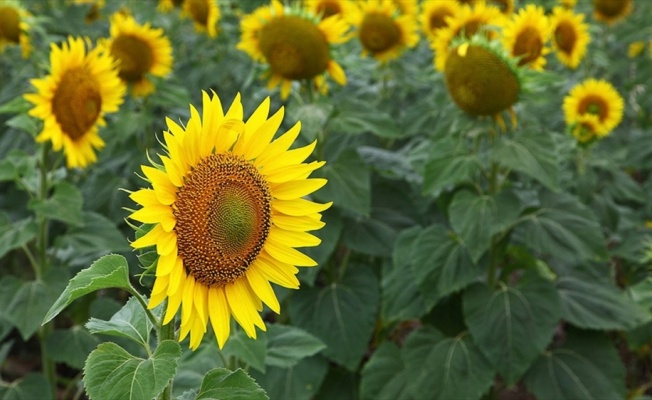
[403,328,496,400]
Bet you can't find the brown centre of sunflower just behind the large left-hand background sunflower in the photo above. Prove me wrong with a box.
[111,35,154,82]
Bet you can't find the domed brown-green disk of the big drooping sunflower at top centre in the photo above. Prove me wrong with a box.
[259,15,330,80]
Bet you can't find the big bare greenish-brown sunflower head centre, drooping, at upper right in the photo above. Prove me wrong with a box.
[444,45,520,115]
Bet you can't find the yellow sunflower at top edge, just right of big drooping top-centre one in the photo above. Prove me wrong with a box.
[352,0,419,62]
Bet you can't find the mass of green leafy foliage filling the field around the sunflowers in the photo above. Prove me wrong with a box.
[0,1,652,399]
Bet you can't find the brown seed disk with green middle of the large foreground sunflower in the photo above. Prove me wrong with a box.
[174,154,271,286]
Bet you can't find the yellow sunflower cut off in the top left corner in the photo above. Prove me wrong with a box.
[0,0,32,58]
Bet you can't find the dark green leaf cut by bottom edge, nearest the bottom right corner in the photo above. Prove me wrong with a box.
[524,331,626,400]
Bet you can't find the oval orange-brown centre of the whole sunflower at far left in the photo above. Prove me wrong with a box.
[52,67,102,141]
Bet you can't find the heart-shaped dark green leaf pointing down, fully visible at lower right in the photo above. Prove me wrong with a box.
[464,274,561,385]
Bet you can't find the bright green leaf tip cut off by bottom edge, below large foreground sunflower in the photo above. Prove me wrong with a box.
[195,368,269,400]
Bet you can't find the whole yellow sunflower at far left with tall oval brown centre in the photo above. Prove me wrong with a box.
[25,37,125,168]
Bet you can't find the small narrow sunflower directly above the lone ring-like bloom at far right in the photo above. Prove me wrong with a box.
[550,7,591,69]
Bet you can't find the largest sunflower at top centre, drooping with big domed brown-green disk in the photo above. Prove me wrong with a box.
[237,0,348,99]
